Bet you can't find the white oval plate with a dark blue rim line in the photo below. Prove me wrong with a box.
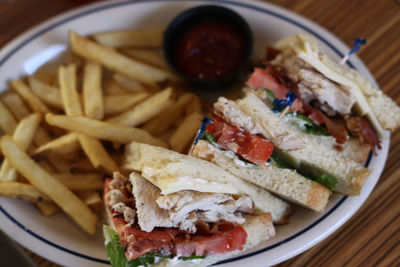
[0,0,389,266]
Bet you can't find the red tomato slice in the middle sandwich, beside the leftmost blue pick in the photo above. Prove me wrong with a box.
[206,117,274,165]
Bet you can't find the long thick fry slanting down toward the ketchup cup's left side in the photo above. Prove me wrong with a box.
[69,31,173,86]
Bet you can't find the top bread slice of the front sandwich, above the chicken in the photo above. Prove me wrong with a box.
[123,142,291,223]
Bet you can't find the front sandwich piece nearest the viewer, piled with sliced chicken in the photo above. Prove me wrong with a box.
[104,143,282,266]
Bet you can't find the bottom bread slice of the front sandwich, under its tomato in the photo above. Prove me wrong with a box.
[154,213,275,267]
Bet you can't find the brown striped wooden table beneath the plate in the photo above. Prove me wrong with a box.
[0,0,400,266]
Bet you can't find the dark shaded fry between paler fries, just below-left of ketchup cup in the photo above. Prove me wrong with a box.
[142,93,195,136]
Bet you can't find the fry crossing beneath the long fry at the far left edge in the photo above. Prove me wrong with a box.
[0,113,42,182]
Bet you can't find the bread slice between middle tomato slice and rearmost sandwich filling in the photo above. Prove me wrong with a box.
[214,95,370,195]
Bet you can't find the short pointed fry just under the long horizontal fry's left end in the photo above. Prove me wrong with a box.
[34,132,80,155]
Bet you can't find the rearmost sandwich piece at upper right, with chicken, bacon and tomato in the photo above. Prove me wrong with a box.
[247,34,400,163]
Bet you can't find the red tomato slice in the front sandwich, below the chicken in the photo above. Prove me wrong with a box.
[175,225,247,257]
